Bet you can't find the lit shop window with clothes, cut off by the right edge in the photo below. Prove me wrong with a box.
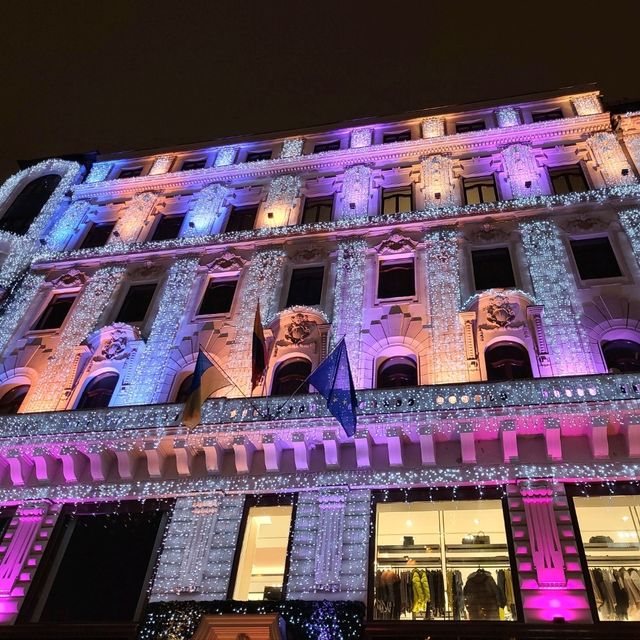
[573,488,640,622]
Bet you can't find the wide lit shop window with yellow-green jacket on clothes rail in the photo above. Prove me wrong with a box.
[373,499,517,621]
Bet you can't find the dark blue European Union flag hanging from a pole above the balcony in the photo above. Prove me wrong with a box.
[309,338,358,438]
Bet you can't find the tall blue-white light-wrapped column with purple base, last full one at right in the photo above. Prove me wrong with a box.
[519,220,596,376]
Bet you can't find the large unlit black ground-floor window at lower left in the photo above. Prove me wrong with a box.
[40,510,162,623]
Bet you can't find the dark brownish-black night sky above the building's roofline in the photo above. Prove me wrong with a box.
[0,0,640,178]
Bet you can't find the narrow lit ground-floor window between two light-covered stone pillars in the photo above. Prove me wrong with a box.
[233,505,293,601]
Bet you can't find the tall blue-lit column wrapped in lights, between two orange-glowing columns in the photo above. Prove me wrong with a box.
[118,258,199,405]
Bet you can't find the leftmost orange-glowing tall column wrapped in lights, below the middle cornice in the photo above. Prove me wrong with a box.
[25,267,125,412]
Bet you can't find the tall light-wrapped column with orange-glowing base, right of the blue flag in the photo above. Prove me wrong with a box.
[424,229,467,384]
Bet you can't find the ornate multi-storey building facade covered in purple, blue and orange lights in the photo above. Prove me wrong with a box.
[0,87,640,640]
